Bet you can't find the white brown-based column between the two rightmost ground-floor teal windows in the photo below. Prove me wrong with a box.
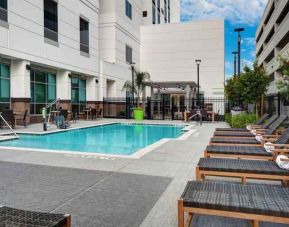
[56,70,71,110]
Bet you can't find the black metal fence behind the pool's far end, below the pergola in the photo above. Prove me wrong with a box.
[103,96,228,120]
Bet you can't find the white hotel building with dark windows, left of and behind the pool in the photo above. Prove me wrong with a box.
[0,0,224,122]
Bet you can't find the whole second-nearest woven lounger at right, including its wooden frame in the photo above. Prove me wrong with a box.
[196,158,289,186]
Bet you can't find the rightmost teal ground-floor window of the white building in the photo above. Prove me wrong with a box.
[71,76,86,113]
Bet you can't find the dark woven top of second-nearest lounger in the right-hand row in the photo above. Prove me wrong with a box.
[198,158,289,176]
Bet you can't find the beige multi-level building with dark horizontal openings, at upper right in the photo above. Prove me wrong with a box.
[256,0,289,95]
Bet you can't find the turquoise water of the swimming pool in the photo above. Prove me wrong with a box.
[0,124,183,155]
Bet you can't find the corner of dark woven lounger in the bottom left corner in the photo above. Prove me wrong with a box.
[0,206,71,227]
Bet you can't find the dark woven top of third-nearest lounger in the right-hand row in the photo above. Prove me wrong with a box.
[206,145,272,157]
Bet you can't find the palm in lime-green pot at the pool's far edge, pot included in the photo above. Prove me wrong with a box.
[122,71,150,121]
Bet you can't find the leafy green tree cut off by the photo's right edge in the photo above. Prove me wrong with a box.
[276,53,289,100]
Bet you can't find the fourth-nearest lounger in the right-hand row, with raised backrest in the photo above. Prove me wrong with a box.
[210,115,287,146]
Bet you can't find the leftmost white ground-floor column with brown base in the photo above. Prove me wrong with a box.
[10,60,31,124]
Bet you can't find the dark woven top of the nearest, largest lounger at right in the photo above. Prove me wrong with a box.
[181,181,289,218]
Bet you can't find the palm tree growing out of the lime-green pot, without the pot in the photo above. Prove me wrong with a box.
[122,71,150,108]
